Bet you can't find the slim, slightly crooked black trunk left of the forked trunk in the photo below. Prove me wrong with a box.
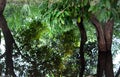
[77,18,87,77]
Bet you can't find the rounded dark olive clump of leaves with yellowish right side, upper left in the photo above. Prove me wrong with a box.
[21,20,47,42]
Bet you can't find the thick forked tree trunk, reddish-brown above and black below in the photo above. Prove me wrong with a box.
[90,15,114,77]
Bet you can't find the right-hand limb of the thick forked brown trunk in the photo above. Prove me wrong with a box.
[104,19,114,77]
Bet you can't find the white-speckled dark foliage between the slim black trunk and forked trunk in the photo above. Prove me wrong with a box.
[85,41,98,75]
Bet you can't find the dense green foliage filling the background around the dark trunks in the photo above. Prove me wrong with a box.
[0,0,120,77]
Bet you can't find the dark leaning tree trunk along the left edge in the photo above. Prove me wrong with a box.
[0,0,16,77]
